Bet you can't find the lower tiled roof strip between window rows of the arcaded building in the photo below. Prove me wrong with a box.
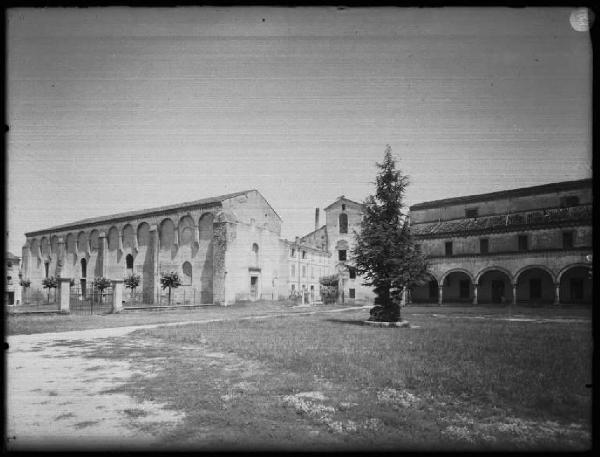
[410,205,592,236]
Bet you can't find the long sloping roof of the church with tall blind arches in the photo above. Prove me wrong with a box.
[25,189,258,236]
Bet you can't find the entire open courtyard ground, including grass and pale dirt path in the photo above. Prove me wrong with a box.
[7,304,592,450]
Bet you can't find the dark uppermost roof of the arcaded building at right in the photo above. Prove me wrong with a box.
[409,178,592,211]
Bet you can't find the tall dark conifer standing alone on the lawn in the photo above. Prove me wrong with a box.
[353,145,427,322]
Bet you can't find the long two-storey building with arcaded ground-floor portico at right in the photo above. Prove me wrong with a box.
[410,179,592,304]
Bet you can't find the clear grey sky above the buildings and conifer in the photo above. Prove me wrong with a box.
[6,7,592,256]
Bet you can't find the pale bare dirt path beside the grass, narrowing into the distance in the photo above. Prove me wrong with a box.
[6,307,370,450]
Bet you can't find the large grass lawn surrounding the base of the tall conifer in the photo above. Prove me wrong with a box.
[70,307,592,451]
